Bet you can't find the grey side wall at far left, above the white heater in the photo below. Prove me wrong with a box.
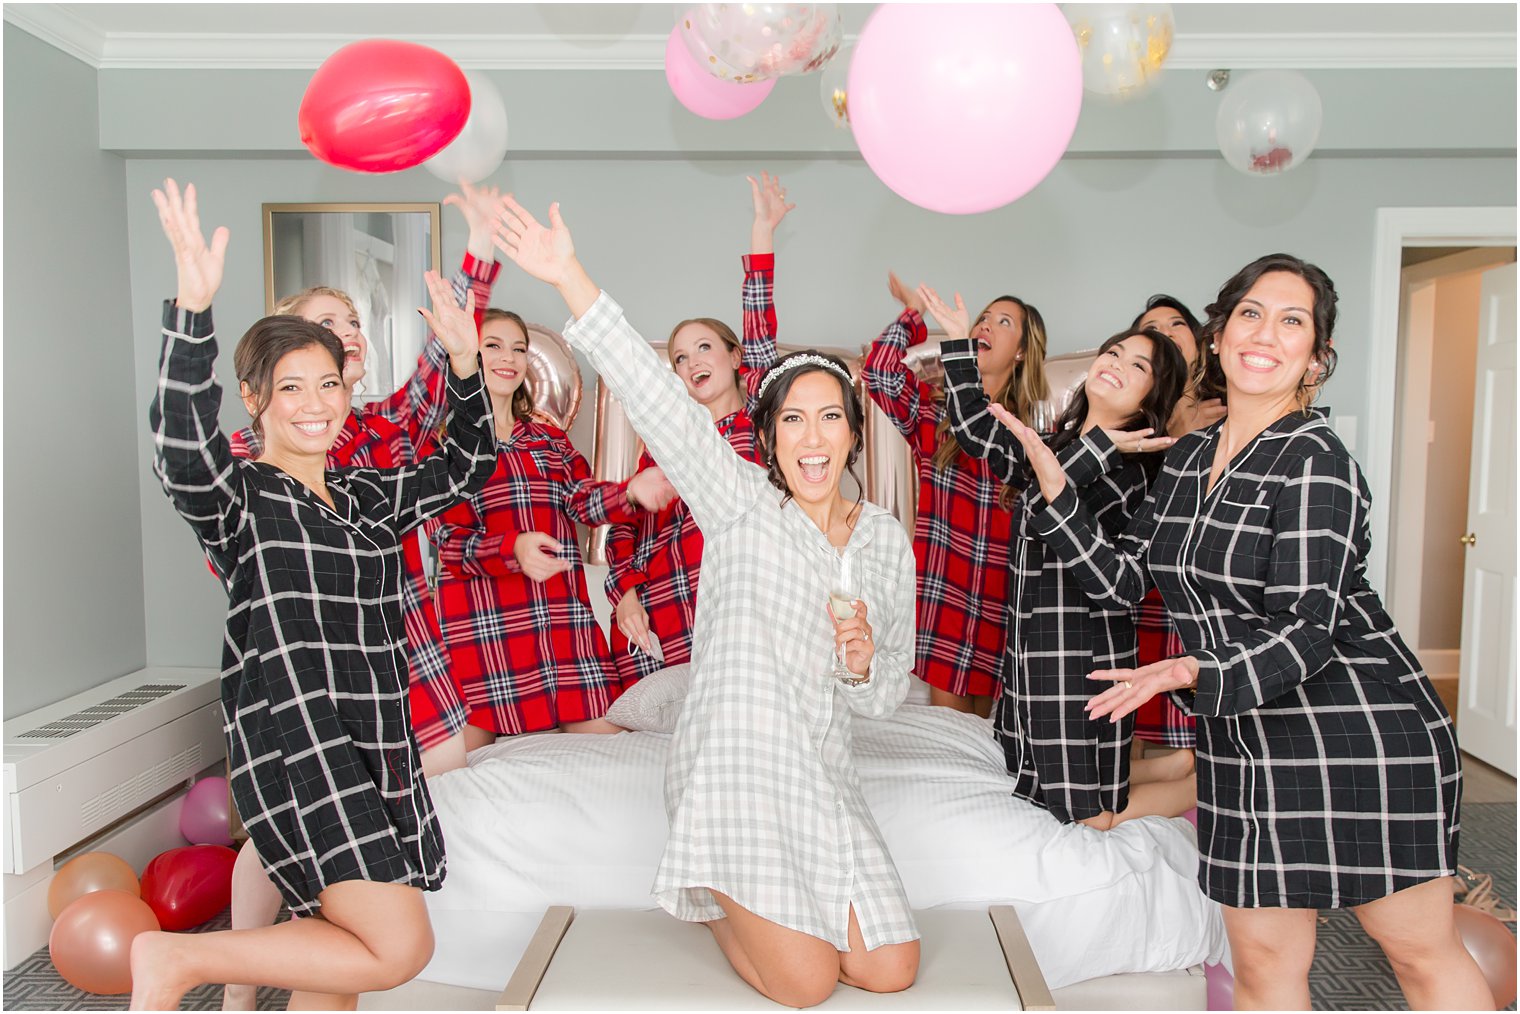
[3,24,146,718]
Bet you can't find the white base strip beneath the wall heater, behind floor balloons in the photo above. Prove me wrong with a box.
[5,762,225,971]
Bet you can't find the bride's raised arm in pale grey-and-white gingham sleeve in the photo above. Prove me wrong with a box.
[497,196,766,532]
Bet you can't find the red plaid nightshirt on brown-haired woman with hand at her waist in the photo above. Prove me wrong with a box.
[432,420,637,736]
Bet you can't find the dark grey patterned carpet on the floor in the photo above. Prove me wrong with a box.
[0,803,1515,1011]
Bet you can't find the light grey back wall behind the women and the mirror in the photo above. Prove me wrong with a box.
[128,158,1515,664]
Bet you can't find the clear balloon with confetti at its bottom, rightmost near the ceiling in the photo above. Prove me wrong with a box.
[1214,70,1324,176]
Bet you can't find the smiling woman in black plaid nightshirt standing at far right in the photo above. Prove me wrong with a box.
[1009,254,1493,1009]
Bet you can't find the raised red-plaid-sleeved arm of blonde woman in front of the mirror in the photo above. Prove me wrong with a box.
[359,182,502,447]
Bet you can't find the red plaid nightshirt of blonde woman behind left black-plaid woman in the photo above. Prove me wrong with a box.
[231,252,502,749]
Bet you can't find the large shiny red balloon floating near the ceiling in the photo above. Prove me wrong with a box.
[296,38,470,172]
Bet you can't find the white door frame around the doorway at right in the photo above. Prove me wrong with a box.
[1363,207,1515,596]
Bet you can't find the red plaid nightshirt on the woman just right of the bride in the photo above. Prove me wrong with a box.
[860,310,1014,696]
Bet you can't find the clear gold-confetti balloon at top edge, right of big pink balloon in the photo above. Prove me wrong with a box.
[1062,3,1175,99]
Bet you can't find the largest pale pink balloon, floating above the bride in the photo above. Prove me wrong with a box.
[847,3,1082,214]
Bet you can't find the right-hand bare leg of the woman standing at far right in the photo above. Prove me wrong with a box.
[1353,877,1494,1011]
